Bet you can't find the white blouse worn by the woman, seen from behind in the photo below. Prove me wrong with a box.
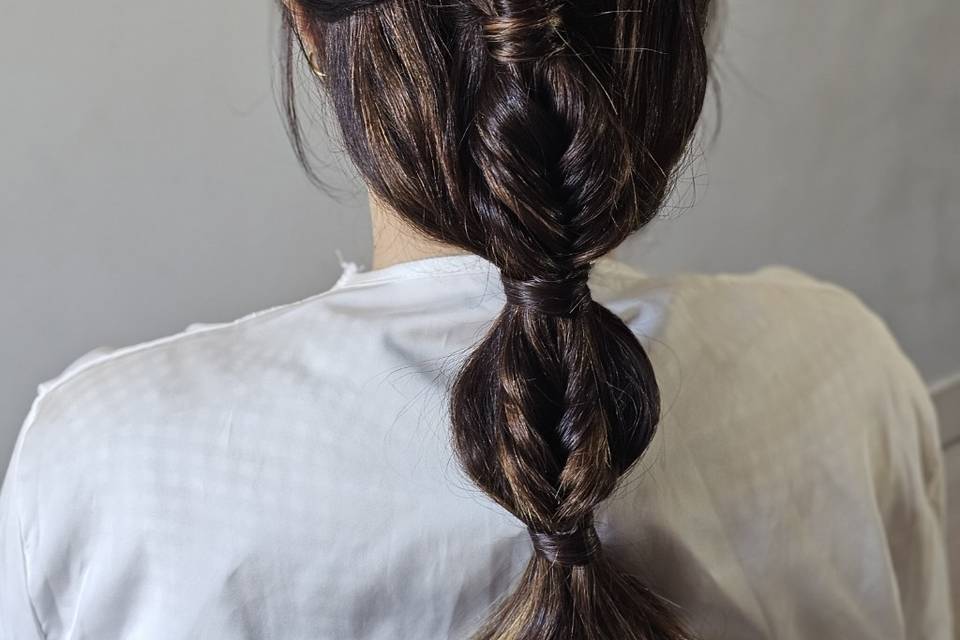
[0,255,952,640]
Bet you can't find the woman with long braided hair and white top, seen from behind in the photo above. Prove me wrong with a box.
[0,0,951,640]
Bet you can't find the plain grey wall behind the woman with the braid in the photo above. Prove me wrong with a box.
[0,0,960,472]
